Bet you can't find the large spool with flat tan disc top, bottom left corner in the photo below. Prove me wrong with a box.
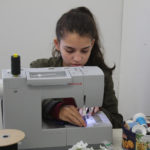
[0,129,25,150]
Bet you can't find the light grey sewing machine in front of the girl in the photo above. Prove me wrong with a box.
[2,66,112,150]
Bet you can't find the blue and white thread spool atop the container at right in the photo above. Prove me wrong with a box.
[133,113,147,127]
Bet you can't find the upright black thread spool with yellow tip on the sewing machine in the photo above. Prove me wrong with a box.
[11,53,21,76]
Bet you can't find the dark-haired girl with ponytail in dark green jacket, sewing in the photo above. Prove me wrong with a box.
[30,7,123,128]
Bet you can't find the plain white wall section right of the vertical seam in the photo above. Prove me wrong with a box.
[119,0,150,119]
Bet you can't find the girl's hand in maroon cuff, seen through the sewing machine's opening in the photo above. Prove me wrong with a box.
[59,105,86,127]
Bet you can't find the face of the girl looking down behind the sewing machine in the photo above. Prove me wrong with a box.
[54,32,95,66]
